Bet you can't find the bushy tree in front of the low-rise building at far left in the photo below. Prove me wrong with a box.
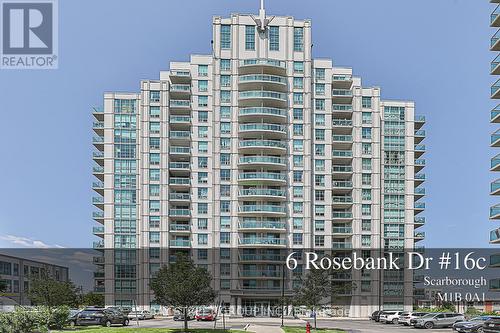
[28,275,80,307]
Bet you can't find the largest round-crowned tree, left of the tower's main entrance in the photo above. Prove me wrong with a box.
[146,255,215,331]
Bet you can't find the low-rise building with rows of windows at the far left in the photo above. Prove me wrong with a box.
[0,254,69,306]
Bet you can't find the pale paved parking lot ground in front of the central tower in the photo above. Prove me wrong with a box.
[120,317,452,333]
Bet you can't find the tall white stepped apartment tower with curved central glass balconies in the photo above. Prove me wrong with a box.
[93,4,425,317]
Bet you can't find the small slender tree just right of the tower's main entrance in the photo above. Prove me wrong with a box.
[295,269,332,329]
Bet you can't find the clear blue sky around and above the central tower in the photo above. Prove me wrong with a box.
[0,0,495,247]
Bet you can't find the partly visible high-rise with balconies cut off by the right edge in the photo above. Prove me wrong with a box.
[490,0,500,291]
